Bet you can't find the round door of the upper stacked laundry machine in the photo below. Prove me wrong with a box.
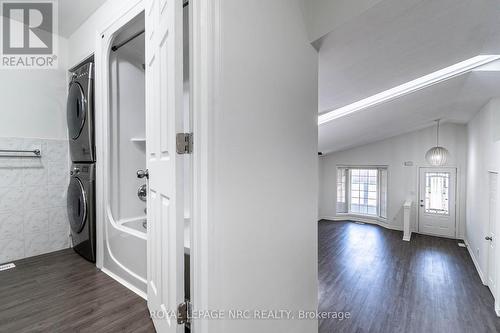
[66,82,87,140]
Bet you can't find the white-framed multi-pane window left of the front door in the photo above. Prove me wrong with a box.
[337,167,387,218]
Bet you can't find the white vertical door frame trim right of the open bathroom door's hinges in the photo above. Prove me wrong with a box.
[189,0,222,333]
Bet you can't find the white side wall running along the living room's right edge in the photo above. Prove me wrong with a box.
[466,99,500,280]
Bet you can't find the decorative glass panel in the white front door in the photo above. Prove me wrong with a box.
[425,172,450,215]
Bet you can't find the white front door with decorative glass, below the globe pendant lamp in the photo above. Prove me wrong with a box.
[418,168,457,238]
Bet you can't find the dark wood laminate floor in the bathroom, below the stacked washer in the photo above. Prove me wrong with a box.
[0,249,155,333]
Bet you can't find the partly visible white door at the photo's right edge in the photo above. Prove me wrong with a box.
[485,172,498,295]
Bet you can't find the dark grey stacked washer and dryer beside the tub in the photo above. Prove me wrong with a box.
[67,61,96,262]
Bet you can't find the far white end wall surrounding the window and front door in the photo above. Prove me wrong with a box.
[319,124,467,238]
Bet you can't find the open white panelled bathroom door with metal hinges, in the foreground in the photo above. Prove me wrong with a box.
[146,0,184,333]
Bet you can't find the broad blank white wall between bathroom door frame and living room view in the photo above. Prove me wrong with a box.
[204,0,318,333]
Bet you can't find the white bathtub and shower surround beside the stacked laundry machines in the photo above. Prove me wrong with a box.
[101,12,147,298]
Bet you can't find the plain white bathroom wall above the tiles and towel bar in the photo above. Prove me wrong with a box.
[0,36,68,139]
